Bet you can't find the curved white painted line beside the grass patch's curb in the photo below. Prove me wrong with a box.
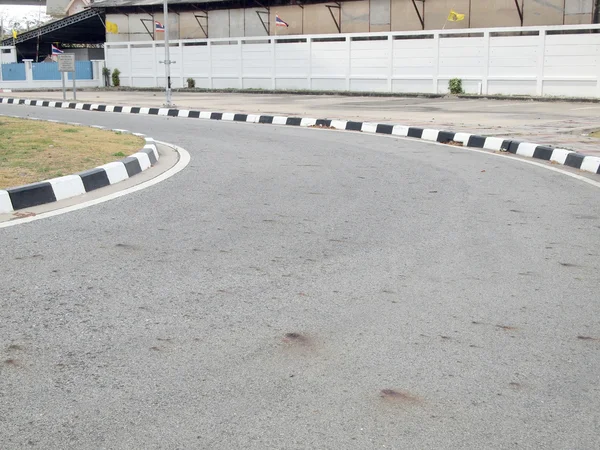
[0,141,190,228]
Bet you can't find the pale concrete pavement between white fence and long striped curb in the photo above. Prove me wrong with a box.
[11,90,600,156]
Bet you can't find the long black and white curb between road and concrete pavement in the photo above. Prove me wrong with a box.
[0,97,600,178]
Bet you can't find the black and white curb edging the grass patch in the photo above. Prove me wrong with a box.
[0,119,159,214]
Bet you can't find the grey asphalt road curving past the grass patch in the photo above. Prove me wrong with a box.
[0,105,600,449]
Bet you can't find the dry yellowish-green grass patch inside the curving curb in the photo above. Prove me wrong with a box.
[0,117,144,189]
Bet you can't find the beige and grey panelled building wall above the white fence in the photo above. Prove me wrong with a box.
[107,0,594,42]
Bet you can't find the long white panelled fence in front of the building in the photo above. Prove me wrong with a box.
[105,25,600,97]
